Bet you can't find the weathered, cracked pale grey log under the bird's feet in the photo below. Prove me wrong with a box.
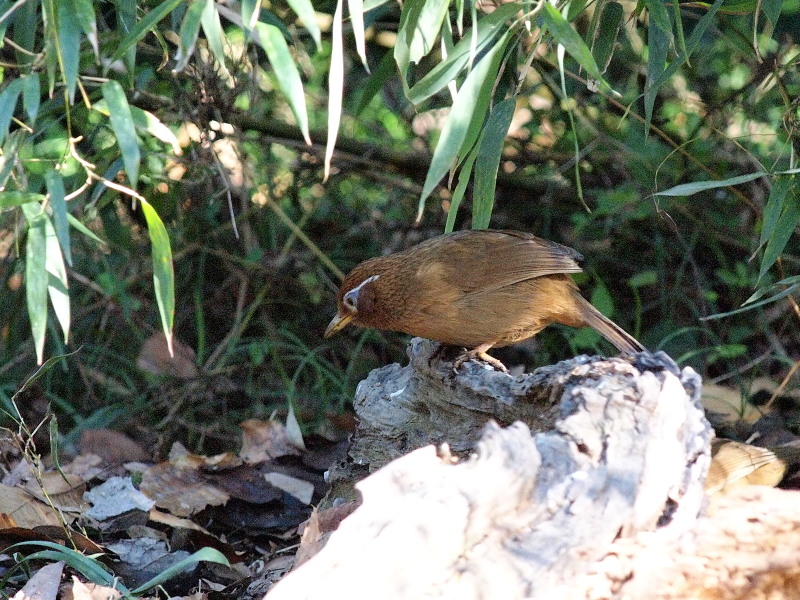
[266,339,800,600]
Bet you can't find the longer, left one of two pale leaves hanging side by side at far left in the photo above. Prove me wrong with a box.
[22,203,48,365]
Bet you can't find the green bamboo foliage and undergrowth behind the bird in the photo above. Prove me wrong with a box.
[0,0,800,452]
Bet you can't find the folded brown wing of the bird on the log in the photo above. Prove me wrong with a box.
[417,229,583,294]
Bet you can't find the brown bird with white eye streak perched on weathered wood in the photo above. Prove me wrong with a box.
[325,229,644,371]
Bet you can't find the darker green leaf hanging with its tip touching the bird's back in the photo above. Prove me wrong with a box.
[472,97,516,229]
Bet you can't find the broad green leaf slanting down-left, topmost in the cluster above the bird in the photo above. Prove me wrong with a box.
[407,3,519,104]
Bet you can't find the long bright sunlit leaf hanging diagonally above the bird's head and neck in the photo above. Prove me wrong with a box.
[417,30,511,220]
